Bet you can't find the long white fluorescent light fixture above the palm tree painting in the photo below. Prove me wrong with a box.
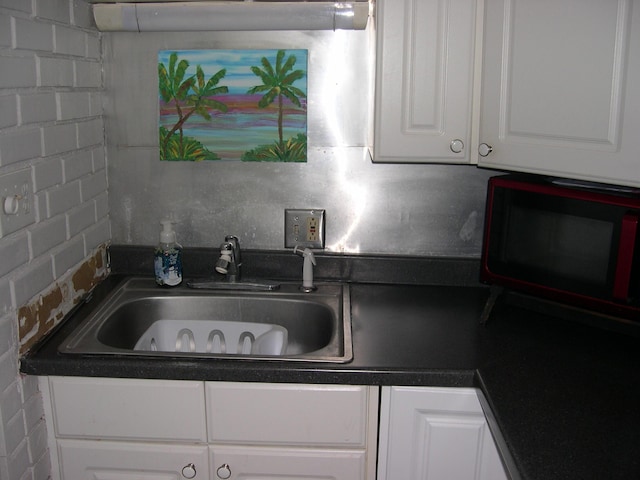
[93,1,369,32]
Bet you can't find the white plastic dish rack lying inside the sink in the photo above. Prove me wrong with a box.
[134,320,287,355]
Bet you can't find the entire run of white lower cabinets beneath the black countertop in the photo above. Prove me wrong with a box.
[40,377,506,480]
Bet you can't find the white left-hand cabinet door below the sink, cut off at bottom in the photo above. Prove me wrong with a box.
[58,440,209,480]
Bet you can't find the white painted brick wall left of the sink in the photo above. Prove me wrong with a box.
[0,0,110,480]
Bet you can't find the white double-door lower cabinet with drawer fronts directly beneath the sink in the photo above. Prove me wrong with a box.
[40,377,379,480]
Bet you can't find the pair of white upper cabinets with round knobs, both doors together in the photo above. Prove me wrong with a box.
[373,0,640,187]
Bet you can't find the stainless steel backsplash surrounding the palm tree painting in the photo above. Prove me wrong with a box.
[103,28,493,257]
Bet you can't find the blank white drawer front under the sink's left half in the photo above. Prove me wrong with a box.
[49,377,207,442]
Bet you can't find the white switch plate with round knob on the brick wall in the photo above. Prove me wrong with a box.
[0,170,36,238]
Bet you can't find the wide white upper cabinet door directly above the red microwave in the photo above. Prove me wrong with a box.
[478,0,640,186]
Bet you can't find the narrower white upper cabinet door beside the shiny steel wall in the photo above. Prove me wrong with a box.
[373,0,476,163]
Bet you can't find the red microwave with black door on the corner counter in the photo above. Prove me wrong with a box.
[480,175,640,321]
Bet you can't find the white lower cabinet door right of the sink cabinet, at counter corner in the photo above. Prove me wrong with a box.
[378,387,507,480]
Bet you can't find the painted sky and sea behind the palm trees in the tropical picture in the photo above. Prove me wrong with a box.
[158,50,307,161]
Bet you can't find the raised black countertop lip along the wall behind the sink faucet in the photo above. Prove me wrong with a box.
[109,245,480,286]
